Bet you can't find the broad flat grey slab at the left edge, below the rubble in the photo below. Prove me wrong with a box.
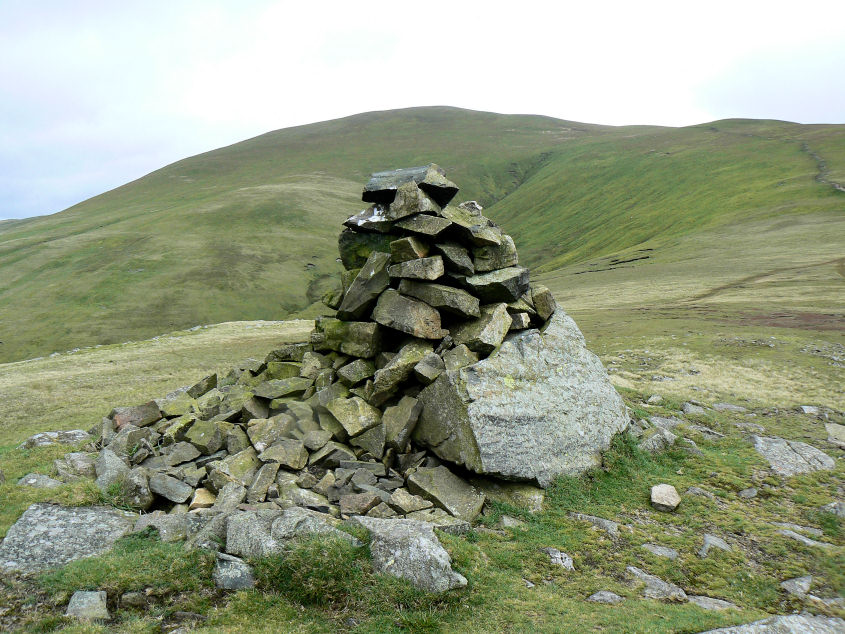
[0,504,138,572]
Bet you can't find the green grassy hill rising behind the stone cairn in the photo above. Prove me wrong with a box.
[0,107,845,361]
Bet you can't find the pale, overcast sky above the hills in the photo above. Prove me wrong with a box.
[0,0,845,220]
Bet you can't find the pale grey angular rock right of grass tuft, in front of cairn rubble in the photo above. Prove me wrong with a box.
[354,516,467,592]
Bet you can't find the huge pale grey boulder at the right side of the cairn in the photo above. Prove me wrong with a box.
[414,309,628,487]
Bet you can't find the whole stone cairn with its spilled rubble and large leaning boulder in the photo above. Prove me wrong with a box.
[16,164,629,589]
